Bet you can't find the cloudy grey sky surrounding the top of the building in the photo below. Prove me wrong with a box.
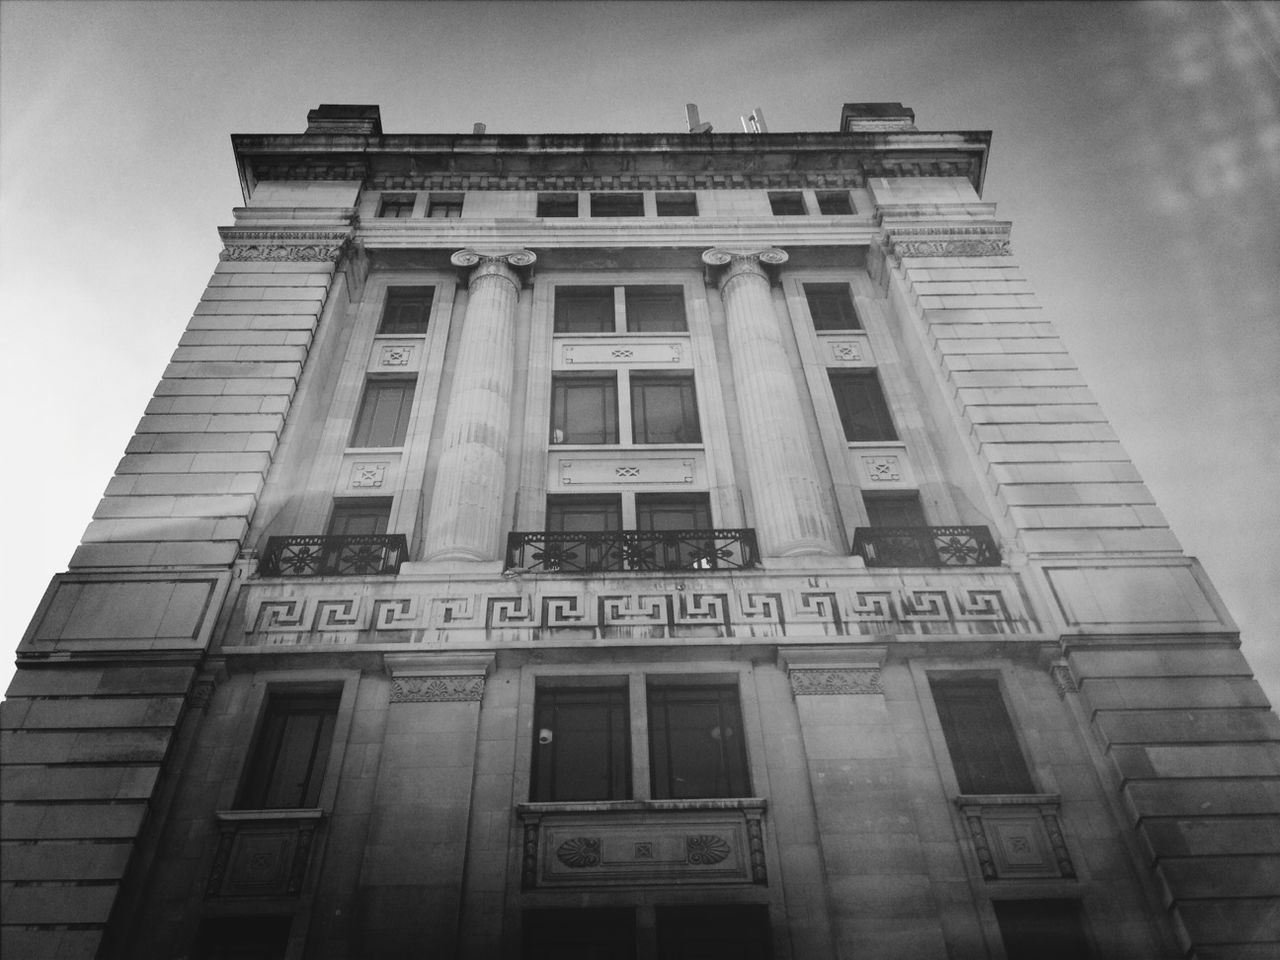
[0,0,1280,701]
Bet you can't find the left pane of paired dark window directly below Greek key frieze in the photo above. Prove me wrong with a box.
[529,685,631,801]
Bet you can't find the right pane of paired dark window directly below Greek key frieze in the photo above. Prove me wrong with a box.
[648,684,751,800]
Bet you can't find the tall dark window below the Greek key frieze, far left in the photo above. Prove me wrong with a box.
[237,692,339,810]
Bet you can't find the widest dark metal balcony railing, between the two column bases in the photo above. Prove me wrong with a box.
[507,529,760,573]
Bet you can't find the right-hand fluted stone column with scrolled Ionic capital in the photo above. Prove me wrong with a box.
[703,247,837,557]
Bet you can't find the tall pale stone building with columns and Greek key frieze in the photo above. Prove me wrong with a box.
[3,104,1280,960]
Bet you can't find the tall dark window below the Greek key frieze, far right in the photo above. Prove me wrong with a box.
[929,677,1036,794]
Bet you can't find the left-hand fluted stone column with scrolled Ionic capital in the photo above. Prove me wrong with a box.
[425,250,535,561]
